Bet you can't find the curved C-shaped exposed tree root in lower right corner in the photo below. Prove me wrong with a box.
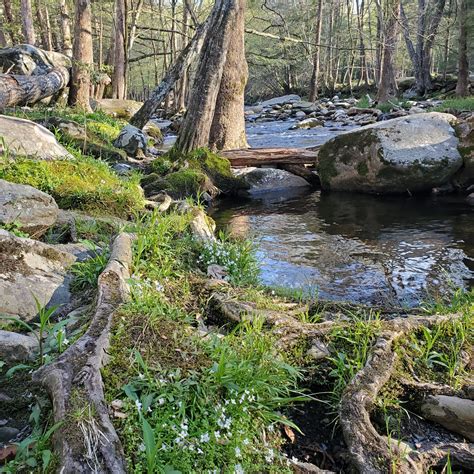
[340,315,474,474]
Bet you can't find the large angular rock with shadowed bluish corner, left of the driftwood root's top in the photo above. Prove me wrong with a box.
[0,229,76,321]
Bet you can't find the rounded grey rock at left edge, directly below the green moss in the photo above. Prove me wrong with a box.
[0,179,59,237]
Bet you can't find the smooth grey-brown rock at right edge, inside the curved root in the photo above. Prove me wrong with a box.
[421,395,474,441]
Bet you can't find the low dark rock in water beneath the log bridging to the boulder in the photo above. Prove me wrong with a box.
[238,168,309,194]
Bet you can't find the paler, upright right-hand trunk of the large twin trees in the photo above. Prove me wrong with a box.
[209,0,248,150]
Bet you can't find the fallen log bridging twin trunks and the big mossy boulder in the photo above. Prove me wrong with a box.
[220,148,318,167]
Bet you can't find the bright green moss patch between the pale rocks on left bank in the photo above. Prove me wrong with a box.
[0,157,144,218]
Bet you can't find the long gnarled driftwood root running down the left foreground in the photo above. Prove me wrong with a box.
[33,234,132,474]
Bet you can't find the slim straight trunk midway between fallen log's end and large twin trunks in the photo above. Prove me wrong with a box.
[112,0,127,99]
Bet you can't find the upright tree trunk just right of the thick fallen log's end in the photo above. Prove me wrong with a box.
[69,0,93,111]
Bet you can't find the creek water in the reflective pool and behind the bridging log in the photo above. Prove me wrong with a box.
[212,122,474,307]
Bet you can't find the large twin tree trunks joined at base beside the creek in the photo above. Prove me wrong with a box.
[176,0,247,153]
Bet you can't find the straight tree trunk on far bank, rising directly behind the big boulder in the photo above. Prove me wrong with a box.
[377,0,400,103]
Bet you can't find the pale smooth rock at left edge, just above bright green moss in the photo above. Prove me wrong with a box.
[0,115,72,160]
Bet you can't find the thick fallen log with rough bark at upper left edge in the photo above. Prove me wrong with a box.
[0,66,69,109]
